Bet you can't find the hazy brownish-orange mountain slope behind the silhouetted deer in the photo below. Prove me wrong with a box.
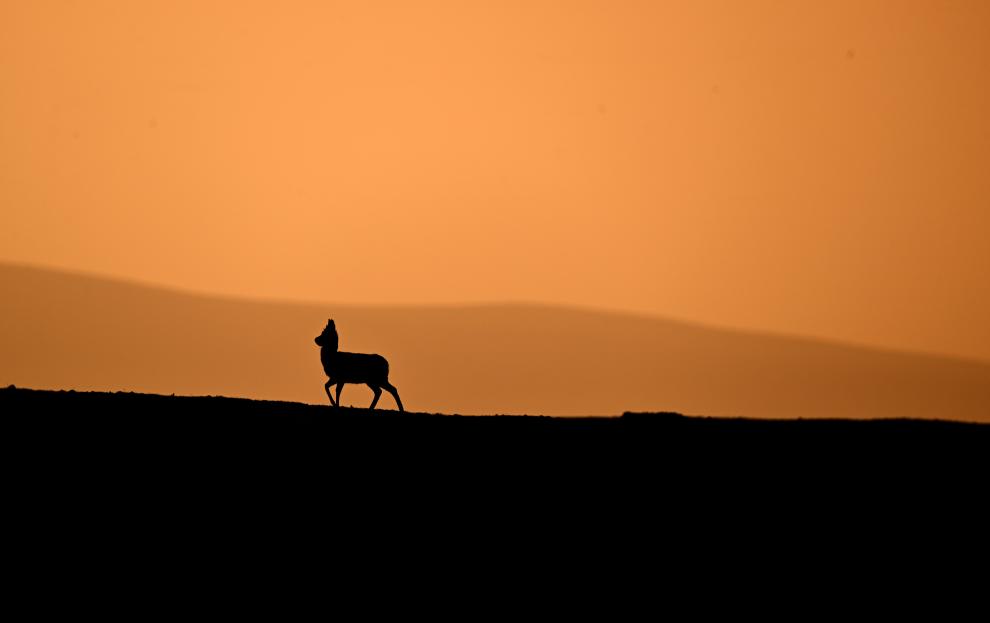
[0,266,990,421]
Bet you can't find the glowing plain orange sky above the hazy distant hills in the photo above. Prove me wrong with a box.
[0,0,990,359]
